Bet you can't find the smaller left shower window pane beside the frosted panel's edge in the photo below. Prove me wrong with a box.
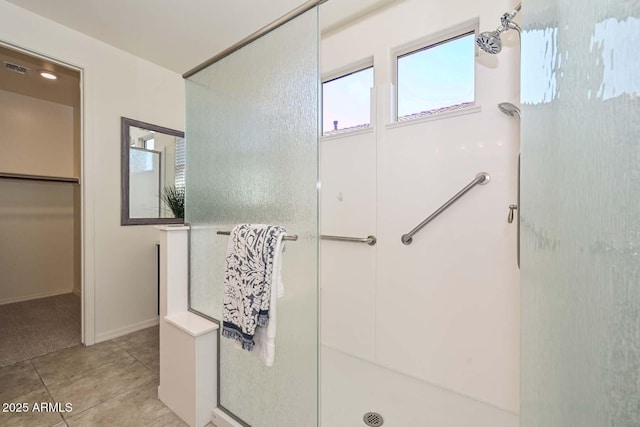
[322,67,373,135]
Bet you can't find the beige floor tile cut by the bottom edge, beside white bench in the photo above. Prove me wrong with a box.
[67,384,187,427]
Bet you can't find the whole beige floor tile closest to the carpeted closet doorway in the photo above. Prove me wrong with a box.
[32,341,128,386]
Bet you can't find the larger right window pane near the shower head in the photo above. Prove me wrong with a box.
[396,32,475,121]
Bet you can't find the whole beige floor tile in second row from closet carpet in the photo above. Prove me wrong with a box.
[48,356,154,413]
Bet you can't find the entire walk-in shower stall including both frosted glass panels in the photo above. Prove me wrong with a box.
[174,0,640,427]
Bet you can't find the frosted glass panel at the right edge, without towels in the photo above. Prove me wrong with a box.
[520,0,640,427]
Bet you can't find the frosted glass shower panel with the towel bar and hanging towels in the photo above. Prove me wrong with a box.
[185,8,320,427]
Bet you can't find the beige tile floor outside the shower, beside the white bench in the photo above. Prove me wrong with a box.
[0,326,186,427]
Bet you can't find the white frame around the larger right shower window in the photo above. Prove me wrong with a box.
[387,18,480,128]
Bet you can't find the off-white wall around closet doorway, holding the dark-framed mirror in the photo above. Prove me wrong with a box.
[0,0,184,343]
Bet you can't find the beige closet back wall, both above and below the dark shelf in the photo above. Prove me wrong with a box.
[0,90,79,304]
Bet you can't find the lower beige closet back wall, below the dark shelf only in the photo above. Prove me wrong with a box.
[0,179,75,304]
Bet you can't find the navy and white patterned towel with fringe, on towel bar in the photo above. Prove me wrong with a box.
[222,224,286,351]
